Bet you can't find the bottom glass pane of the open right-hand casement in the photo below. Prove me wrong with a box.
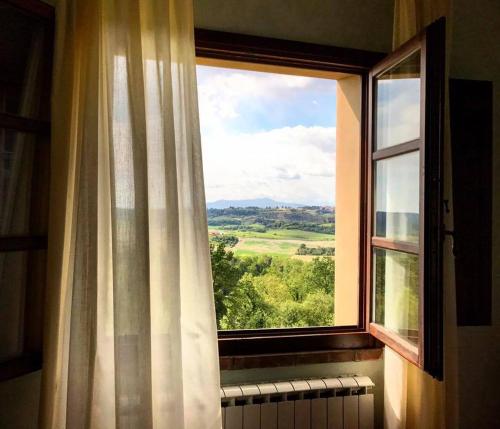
[373,248,419,344]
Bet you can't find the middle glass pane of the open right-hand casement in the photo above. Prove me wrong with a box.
[375,151,420,243]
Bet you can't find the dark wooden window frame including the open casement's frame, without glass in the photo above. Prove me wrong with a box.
[195,22,445,379]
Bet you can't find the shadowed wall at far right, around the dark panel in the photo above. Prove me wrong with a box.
[450,0,500,429]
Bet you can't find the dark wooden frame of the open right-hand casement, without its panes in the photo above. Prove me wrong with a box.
[366,18,445,379]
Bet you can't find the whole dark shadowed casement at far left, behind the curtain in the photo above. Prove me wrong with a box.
[0,2,53,381]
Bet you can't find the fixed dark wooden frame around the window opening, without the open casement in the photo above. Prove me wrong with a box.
[195,29,385,369]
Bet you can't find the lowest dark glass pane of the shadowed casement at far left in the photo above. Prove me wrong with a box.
[0,250,46,362]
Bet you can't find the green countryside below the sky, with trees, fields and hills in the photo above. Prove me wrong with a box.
[207,207,335,329]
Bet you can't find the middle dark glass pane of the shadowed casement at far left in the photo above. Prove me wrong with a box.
[0,129,49,235]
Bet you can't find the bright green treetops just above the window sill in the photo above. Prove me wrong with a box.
[210,242,335,329]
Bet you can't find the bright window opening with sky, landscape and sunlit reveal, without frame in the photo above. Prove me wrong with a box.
[197,64,361,330]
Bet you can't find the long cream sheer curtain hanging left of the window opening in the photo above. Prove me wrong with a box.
[40,0,221,429]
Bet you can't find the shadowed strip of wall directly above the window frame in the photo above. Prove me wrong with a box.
[194,0,393,52]
